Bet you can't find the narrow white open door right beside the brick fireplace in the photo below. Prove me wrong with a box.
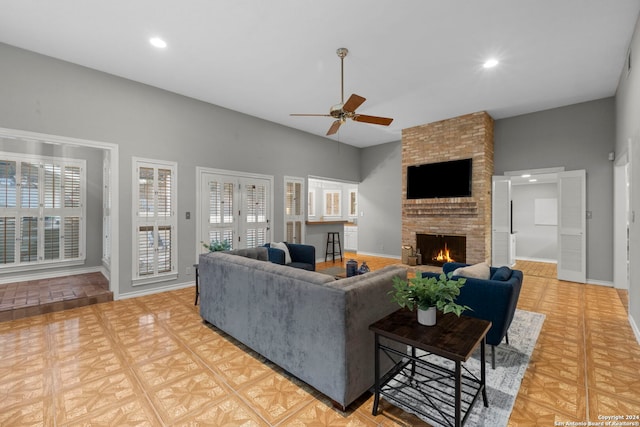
[491,176,511,266]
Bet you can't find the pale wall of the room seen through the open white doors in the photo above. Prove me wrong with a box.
[511,184,558,262]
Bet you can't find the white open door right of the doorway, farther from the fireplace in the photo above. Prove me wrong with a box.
[558,170,587,283]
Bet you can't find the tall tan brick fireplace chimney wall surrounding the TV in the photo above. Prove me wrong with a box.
[402,112,493,264]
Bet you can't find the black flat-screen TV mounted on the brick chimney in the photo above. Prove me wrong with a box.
[407,159,472,199]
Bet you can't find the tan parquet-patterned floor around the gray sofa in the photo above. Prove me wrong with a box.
[0,255,640,426]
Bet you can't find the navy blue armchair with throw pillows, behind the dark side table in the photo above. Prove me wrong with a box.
[422,262,523,369]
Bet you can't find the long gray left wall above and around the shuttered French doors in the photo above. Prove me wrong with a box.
[0,44,360,294]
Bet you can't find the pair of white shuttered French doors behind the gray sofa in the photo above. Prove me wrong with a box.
[196,168,273,254]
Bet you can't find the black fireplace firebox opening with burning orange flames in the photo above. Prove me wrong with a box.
[416,234,467,266]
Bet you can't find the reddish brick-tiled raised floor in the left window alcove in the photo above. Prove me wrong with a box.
[0,273,113,322]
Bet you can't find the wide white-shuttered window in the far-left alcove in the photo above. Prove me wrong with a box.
[0,153,86,270]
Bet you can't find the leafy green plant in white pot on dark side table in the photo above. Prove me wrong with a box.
[389,273,470,326]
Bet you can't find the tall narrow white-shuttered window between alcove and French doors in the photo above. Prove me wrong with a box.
[133,158,177,285]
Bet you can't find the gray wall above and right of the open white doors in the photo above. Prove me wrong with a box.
[494,98,615,282]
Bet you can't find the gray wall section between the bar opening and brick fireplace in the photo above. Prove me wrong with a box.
[358,141,402,258]
